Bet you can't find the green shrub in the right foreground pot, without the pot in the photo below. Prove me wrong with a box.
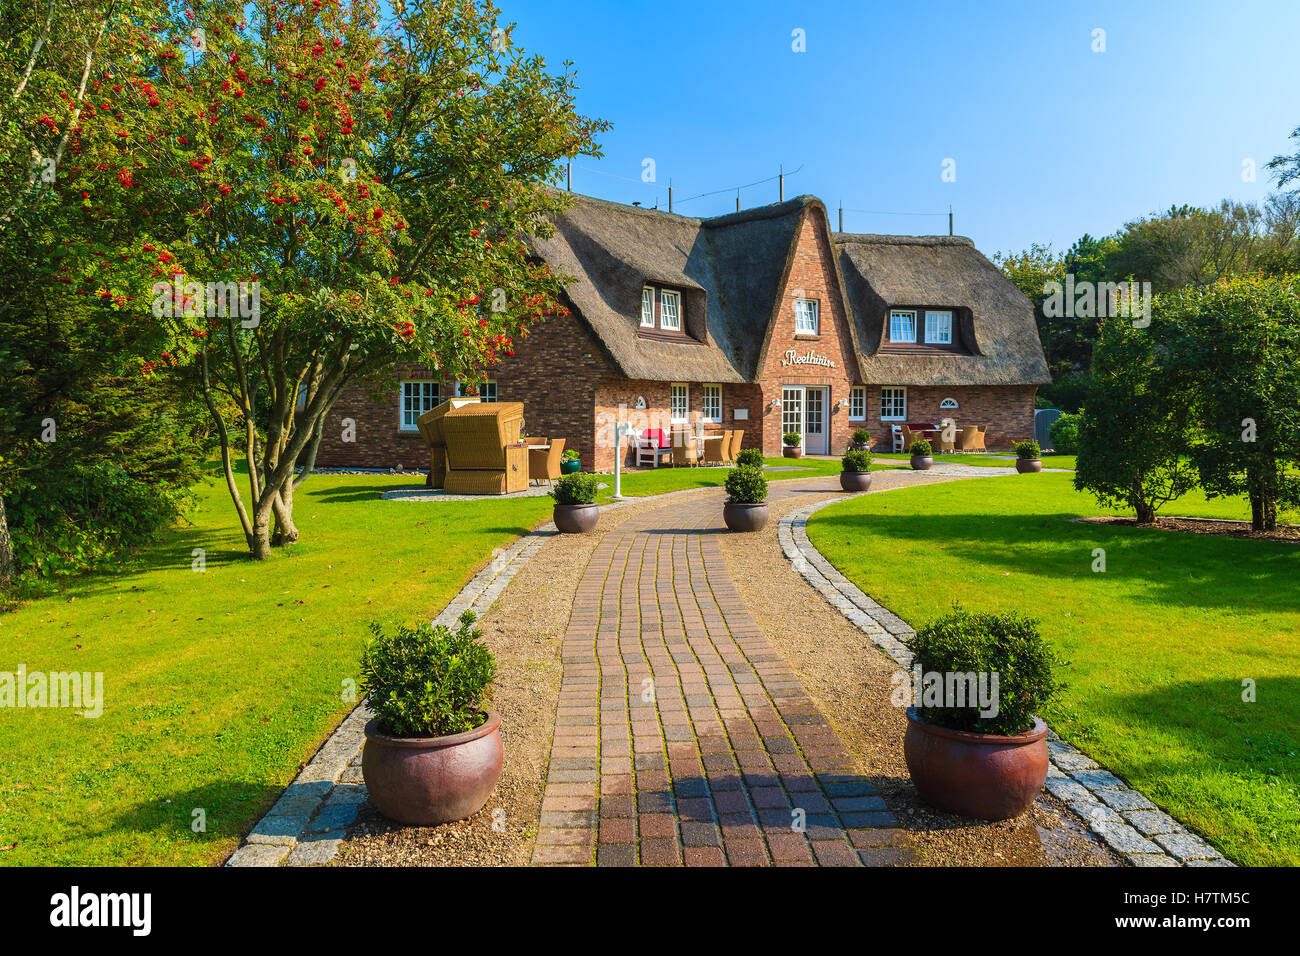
[905,606,1065,736]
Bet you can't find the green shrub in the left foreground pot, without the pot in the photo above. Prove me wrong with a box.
[361,611,497,737]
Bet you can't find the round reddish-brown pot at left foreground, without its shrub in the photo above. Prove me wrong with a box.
[361,711,506,826]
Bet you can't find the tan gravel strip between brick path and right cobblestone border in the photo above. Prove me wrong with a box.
[723,472,1122,866]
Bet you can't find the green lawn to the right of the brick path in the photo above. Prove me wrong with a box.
[809,475,1300,865]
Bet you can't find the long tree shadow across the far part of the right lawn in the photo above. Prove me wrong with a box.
[813,509,1300,613]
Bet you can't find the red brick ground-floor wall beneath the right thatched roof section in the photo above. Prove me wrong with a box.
[854,385,1037,451]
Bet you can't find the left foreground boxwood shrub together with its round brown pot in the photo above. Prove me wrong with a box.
[361,611,504,826]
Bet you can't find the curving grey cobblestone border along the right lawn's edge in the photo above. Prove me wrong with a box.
[777,489,1235,866]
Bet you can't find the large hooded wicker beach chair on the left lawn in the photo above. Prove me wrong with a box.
[441,402,528,494]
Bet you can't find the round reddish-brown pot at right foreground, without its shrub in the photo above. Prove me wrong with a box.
[902,708,1048,819]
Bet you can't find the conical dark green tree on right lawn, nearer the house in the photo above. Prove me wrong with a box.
[1074,313,1196,524]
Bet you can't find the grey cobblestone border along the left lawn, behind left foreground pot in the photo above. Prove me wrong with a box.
[225,522,555,866]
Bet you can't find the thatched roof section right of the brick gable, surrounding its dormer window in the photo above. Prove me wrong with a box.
[833,233,1052,385]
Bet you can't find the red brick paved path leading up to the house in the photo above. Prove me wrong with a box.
[533,483,913,866]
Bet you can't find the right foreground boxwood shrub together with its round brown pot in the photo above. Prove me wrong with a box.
[904,607,1058,819]
